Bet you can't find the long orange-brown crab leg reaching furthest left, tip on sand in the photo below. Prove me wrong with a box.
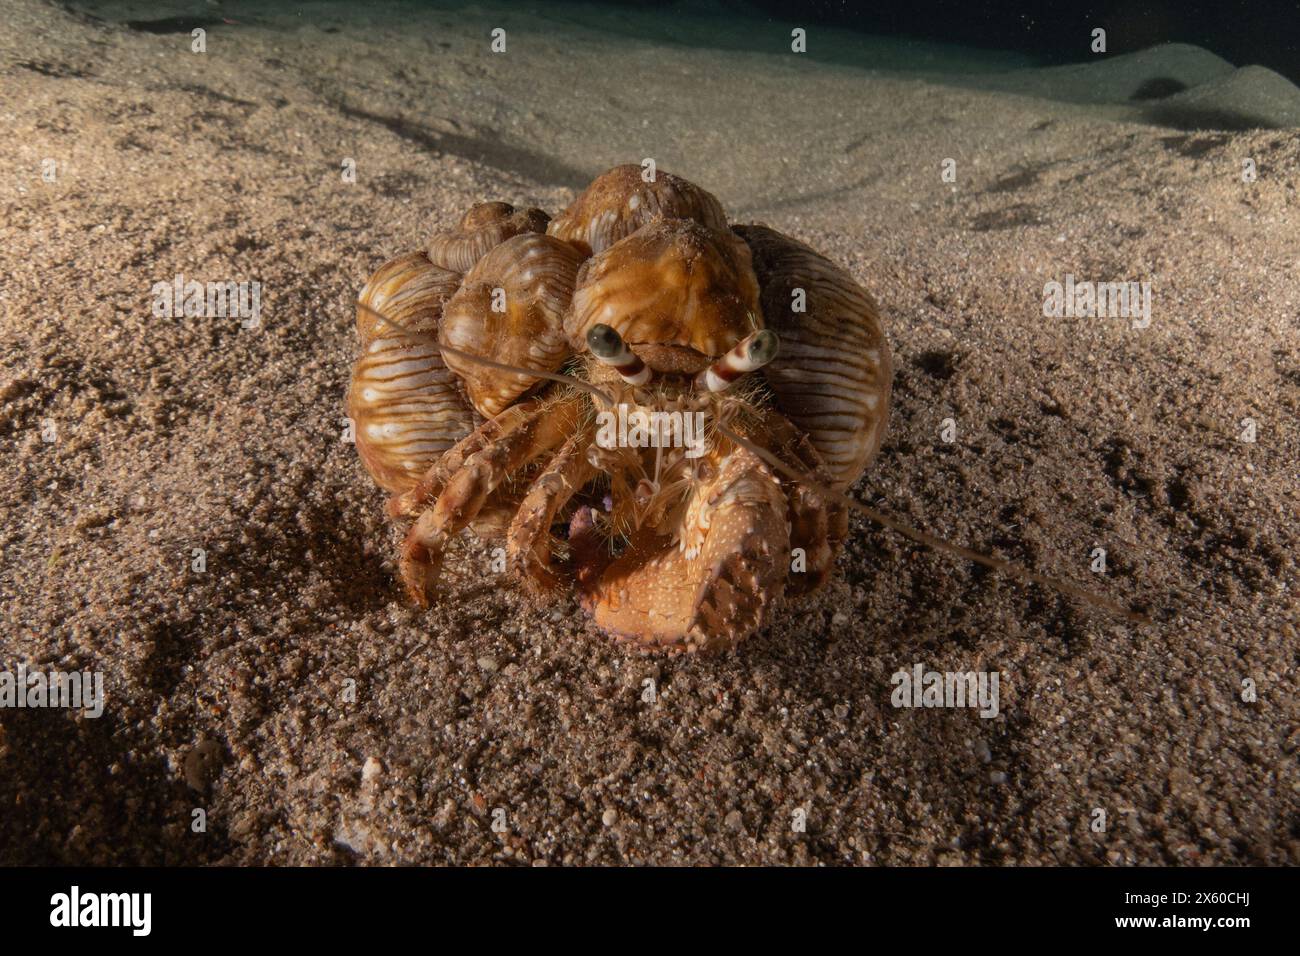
[398,402,577,607]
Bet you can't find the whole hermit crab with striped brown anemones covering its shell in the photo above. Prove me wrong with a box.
[347,165,891,650]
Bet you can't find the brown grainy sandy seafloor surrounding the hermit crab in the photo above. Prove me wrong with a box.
[0,0,1300,865]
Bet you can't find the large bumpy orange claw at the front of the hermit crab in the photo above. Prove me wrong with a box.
[569,447,789,652]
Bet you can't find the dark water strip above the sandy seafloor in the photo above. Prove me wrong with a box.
[76,0,1300,85]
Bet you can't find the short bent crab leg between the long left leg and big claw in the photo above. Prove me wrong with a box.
[506,434,595,596]
